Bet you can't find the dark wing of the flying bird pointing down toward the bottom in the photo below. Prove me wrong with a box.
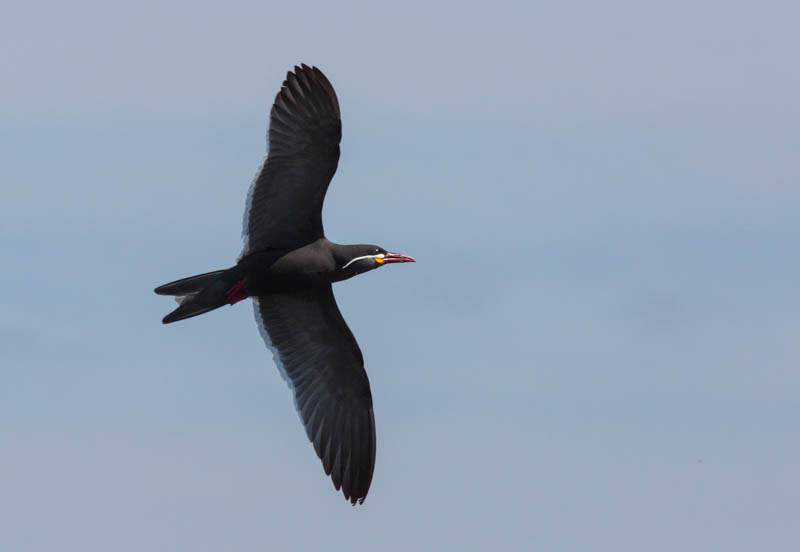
[254,286,375,504]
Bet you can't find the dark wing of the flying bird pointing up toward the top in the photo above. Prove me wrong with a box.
[243,64,342,254]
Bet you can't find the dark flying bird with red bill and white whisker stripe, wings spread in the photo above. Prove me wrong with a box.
[155,64,415,505]
